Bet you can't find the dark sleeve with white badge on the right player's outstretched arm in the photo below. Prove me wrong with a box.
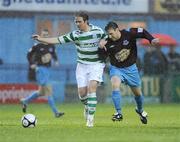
[130,28,154,43]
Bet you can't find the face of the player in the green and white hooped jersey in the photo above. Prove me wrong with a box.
[75,17,88,31]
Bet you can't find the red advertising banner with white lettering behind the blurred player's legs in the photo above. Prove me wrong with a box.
[0,84,47,103]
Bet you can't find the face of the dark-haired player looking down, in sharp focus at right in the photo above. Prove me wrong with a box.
[107,28,121,41]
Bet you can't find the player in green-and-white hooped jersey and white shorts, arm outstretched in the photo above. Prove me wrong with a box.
[32,11,105,127]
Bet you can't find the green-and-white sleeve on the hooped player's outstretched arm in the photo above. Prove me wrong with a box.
[58,32,75,44]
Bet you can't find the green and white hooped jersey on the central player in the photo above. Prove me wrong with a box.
[58,25,106,64]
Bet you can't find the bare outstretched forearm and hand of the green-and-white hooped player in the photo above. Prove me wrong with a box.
[32,34,59,44]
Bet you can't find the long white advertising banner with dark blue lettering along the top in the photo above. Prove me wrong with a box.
[0,0,148,13]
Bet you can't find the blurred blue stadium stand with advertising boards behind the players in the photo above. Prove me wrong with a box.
[0,0,180,104]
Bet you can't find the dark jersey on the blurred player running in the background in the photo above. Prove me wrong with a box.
[27,43,57,67]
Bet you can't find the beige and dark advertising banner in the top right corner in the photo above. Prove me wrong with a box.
[154,0,180,14]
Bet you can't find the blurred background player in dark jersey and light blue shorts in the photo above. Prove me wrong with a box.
[21,29,64,117]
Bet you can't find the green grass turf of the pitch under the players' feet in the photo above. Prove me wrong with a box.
[0,104,180,142]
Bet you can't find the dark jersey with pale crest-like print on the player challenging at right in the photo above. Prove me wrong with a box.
[98,28,154,68]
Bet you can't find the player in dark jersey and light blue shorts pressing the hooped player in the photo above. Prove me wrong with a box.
[99,22,159,124]
